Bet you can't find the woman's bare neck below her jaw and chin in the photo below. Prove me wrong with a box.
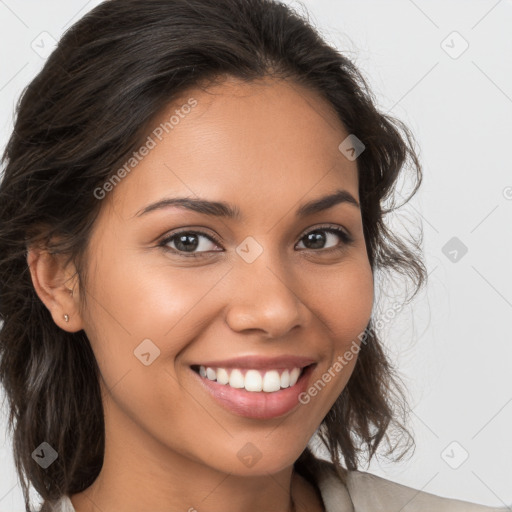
[67,402,311,512]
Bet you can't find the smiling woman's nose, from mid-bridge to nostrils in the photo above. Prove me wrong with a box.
[226,251,309,338]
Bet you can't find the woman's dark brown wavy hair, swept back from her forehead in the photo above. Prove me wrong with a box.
[0,0,426,512]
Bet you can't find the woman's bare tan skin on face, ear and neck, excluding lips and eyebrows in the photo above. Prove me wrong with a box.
[28,78,373,512]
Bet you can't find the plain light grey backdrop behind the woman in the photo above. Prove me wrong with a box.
[0,0,512,512]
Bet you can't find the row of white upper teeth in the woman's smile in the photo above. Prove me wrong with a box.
[194,366,302,393]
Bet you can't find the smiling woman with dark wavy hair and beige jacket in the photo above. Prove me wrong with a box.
[0,0,499,512]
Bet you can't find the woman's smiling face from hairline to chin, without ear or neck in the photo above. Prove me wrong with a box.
[78,75,373,475]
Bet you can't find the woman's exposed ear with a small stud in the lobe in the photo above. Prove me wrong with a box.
[27,246,83,332]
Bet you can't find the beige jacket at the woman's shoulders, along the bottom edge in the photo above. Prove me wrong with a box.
[41,460,512,512]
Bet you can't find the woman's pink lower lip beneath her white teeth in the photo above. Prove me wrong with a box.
[191,364,316,420]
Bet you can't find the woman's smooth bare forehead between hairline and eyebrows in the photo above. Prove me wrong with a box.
[102,78,358,218]
